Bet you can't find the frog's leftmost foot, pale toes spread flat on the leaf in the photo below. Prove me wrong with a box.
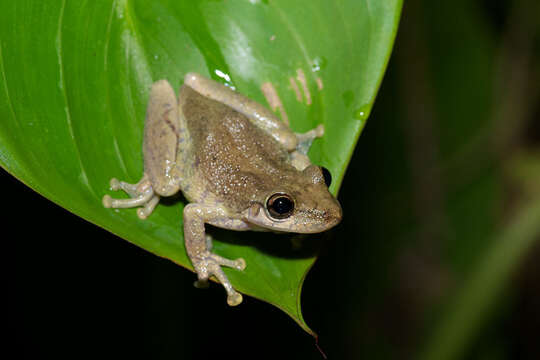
[103,176,159,219]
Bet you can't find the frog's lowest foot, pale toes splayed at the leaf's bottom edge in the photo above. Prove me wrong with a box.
[192,251,246,306]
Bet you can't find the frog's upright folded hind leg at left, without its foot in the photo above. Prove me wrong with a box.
[143,80,184,196]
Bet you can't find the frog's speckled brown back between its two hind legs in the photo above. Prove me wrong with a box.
[180,86,296,210]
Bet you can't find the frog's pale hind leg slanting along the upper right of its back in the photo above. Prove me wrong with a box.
[184,73,298,151]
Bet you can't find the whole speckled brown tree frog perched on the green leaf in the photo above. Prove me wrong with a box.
[102,72,342,306]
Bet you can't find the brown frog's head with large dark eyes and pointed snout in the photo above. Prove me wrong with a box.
[245,165,342,234]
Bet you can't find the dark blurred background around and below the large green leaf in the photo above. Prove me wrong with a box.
[5,0,540,359]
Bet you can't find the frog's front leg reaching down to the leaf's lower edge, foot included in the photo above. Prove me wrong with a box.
[184,203,246,306]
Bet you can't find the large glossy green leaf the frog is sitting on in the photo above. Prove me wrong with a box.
[0,0,401,331]
